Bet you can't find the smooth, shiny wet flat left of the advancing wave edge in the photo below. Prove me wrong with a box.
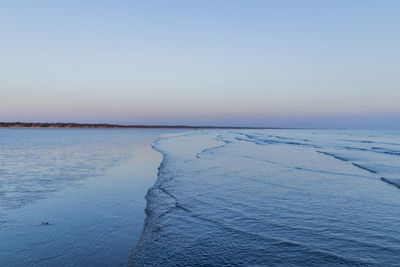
[0,129,177,266]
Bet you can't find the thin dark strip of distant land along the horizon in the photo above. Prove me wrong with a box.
[0,122,272,129]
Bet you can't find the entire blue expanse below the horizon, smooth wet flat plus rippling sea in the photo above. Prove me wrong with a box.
[0,129,400,266]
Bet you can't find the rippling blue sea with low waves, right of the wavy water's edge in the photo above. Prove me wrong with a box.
[130,130,400,266]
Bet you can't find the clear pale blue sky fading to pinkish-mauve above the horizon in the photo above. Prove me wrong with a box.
[0,0,400,129]
